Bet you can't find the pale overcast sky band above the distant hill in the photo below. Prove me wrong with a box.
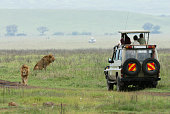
[0,0,170,15]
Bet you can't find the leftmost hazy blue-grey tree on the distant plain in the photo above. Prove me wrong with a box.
[6,25,18,36]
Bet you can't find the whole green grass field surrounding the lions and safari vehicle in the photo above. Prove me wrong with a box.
[0,49,170,114]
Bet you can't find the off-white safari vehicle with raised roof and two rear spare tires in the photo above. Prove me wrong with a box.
[104,30,161,91]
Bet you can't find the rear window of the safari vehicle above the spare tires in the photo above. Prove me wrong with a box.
[126,49,153,62]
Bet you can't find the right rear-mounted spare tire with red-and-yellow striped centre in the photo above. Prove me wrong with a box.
[142,58,160,76]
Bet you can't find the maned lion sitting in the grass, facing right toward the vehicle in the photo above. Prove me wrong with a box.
[34,54,55,70]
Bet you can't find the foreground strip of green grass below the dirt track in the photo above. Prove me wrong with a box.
[0,88,170,113]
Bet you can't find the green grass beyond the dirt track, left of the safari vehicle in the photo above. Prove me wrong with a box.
[0,50,107,88]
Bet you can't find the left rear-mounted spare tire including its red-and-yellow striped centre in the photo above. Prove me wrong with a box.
[122,58,141,76]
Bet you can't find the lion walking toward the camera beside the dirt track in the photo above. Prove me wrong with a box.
[21,64,29,85]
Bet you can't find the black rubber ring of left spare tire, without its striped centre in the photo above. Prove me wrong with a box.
[123,58,141,76]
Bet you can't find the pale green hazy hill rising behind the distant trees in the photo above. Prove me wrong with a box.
[0,9,170,35]
